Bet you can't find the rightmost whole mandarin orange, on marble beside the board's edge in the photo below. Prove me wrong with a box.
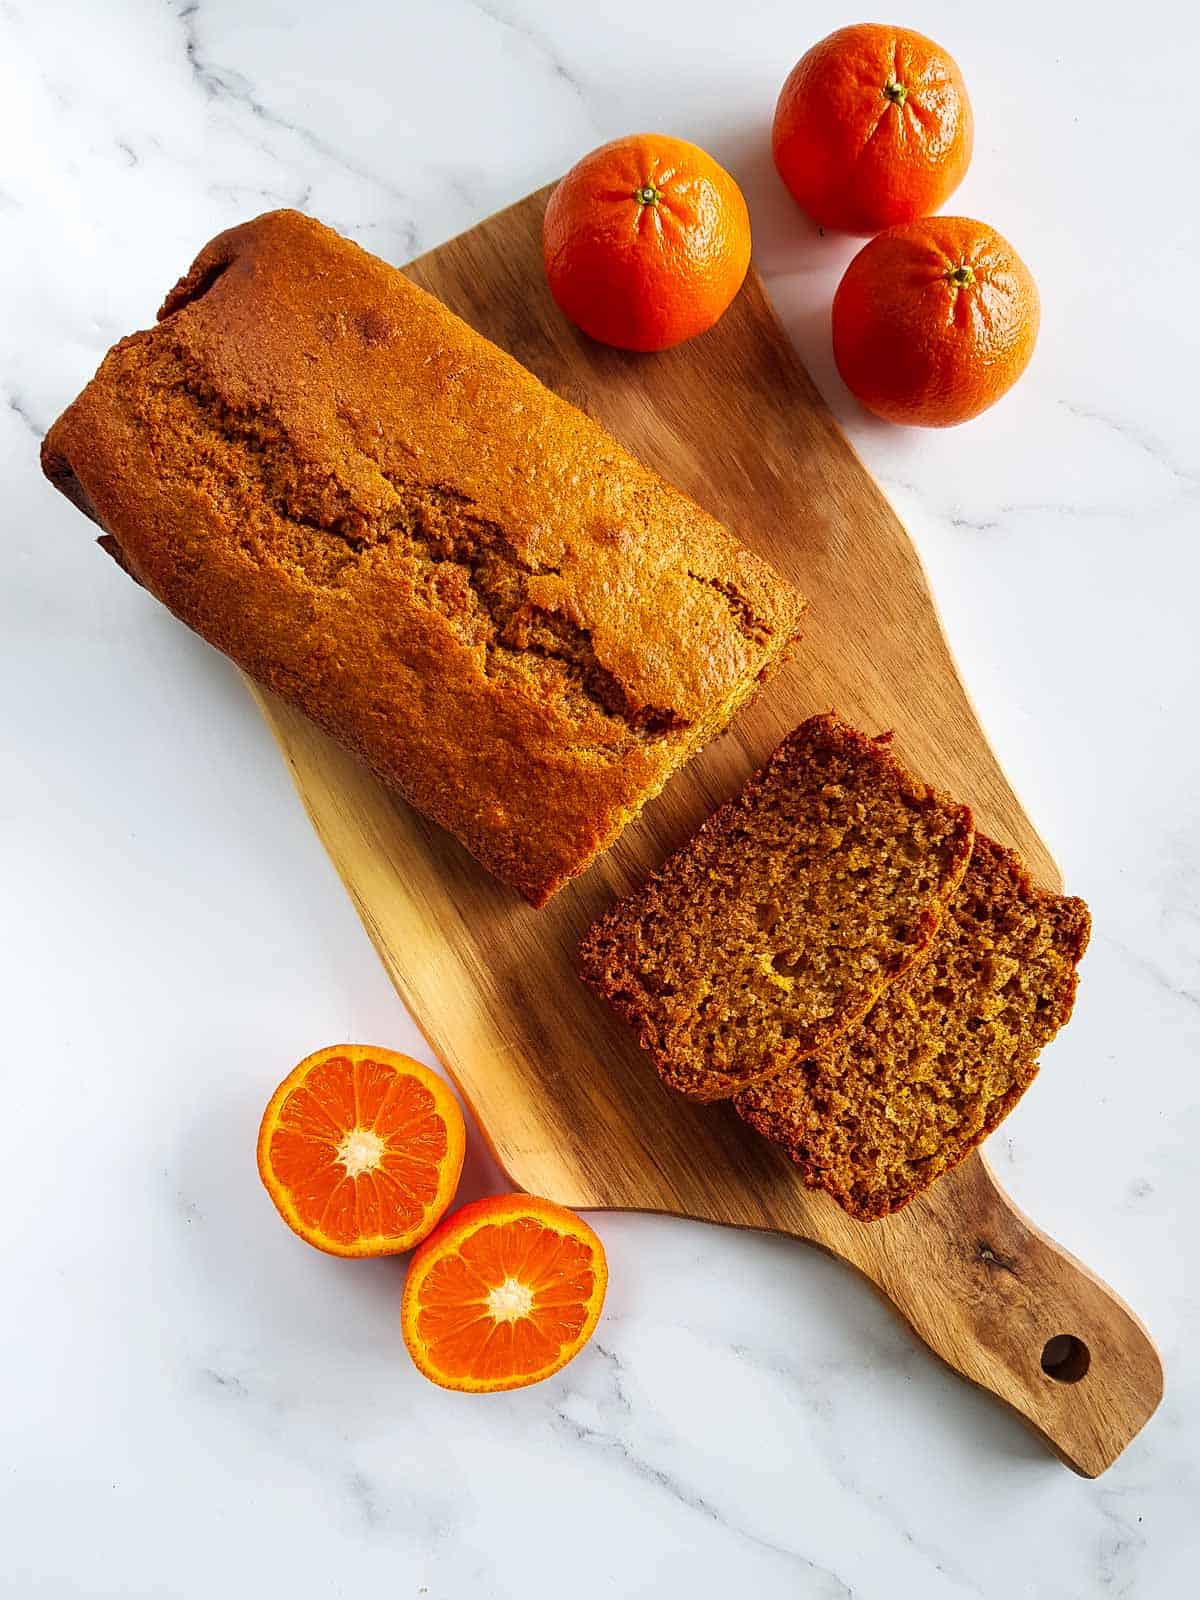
[834,216,1040,427]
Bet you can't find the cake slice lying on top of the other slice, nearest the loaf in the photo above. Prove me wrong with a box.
[581,714,974,1101]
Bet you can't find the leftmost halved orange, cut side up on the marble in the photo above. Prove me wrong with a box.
[258,1045,467,1256]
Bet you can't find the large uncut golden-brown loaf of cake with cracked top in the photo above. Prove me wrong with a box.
[43,211,803,906]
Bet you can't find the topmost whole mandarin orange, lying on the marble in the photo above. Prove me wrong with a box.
[771,22,974,234]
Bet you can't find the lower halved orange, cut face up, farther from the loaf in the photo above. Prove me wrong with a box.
[400,1195,608,1394]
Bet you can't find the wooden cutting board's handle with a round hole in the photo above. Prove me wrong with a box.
[848,1155,1163,1478]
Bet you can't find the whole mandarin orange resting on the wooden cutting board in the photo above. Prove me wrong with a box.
[542,133,750,350]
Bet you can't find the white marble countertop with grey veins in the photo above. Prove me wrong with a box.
[0,0,1200,1600]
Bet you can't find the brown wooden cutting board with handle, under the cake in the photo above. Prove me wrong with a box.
[246,190,1162,1477]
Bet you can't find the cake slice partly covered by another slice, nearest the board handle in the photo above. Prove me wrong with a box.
[734,835,1091,1222]
